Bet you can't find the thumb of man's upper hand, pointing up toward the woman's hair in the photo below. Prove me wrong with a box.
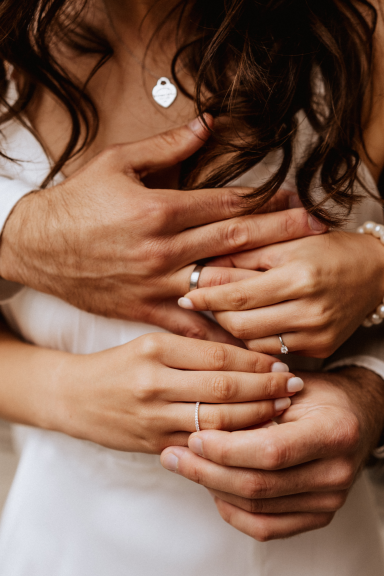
[122,114,213,178]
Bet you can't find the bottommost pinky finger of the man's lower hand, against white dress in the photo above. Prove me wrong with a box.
[215,498,335,542]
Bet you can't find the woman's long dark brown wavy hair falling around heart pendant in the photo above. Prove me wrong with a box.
[0,0,377,225]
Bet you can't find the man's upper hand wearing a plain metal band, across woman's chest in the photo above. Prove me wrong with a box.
[0,118,324,343]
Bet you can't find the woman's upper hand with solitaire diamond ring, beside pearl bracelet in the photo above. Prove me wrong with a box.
[179,232,384,358]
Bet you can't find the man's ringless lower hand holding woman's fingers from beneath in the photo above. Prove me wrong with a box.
[161,368,384,541]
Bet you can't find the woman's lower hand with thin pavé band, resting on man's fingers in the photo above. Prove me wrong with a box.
[54,334,303,453]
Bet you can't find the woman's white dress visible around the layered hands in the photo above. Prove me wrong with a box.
[0,118,384,576]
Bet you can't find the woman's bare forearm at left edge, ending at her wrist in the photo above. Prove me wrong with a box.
[0,321,69,429]
